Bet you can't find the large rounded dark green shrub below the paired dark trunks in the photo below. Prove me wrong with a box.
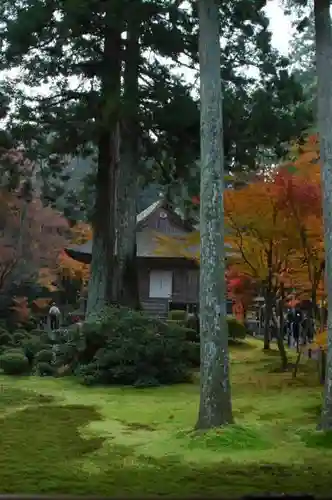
[71,308,194,387]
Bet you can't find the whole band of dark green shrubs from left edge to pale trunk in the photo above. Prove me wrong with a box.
[0,308,199,387]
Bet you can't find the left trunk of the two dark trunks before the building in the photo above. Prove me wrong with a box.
[86,5,121,317]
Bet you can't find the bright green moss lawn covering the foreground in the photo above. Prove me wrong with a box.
[0,341,332,496]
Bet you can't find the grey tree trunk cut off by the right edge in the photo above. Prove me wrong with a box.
[314,0,332,430]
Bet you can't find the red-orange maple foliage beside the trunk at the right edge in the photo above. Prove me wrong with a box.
[275,135,325,317]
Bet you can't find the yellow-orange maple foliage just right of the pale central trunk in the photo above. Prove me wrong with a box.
[224,179,297,287]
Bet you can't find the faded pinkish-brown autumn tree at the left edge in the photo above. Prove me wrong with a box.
[0,188,68,292]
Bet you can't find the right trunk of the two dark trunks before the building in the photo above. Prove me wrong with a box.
[117,4,140,309]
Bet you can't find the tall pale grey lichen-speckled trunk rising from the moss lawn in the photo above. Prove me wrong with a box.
[196,0,233,429]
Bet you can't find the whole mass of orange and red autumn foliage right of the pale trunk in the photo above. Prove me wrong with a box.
[225,136,324,302]
